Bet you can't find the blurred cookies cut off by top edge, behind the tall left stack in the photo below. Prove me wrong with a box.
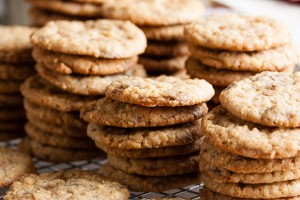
[27,0,104,26]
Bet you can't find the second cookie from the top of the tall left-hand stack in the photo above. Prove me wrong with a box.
[32,48,137,75]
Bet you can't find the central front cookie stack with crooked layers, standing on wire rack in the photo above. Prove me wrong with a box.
[81,76,214,191]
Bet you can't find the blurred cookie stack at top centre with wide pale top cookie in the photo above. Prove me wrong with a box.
[103,0,204,78]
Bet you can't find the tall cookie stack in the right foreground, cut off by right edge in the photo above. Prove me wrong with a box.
[200,72,300,200]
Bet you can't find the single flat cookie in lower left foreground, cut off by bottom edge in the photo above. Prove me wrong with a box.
[4,170,129,200]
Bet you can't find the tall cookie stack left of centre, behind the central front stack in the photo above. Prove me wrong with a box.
[22,20,146,162]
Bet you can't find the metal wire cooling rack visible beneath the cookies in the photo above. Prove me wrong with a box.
[0,140,201,200]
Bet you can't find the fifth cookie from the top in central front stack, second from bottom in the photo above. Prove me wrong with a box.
[107,154,199,176]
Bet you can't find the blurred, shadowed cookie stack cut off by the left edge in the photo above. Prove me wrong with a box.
[0,26,35,141]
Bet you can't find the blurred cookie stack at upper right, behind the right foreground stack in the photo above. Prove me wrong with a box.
[184,14,297,104]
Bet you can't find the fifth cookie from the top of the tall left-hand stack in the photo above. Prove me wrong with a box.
[24,98,87,128]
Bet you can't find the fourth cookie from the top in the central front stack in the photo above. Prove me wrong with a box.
[95,139,201,158]
